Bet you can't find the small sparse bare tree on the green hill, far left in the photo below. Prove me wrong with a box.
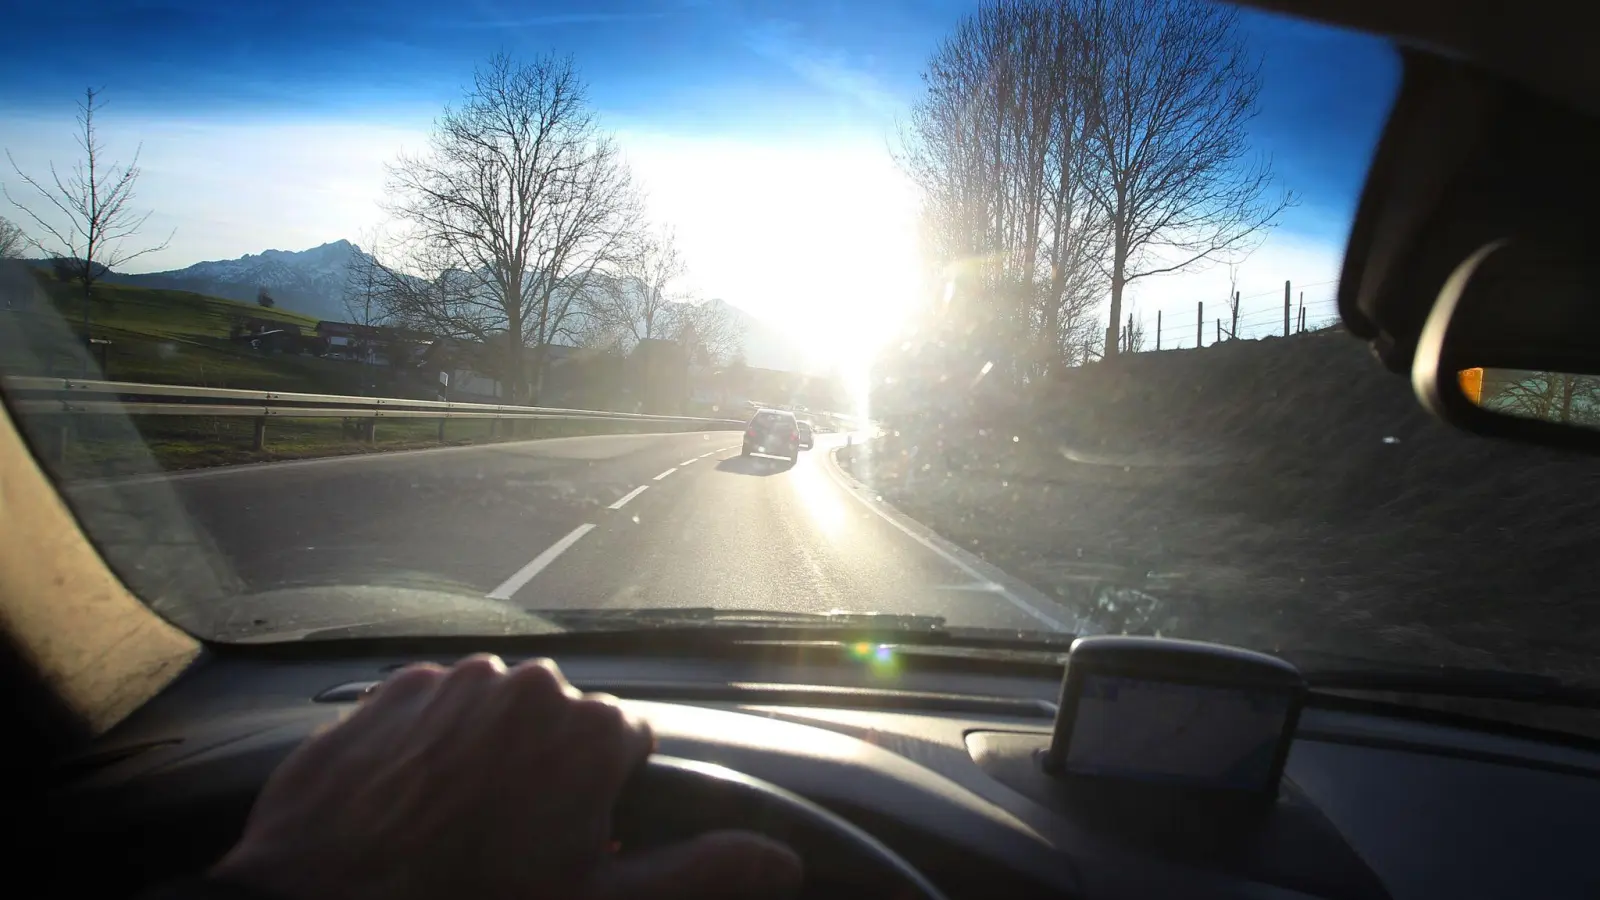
[5,88,176,338]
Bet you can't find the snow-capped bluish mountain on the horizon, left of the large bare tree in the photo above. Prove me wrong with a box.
[115,240,362,320]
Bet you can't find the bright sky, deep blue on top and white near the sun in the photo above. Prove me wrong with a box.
[0,0,1398,365]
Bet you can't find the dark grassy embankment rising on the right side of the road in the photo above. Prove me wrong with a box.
[856,325,1600,698]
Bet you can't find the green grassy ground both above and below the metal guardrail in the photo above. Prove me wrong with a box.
[0,264,490,479]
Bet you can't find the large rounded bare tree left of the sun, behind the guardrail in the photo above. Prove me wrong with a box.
[379,54,638,402]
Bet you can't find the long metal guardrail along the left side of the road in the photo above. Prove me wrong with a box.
[3,376,744,455]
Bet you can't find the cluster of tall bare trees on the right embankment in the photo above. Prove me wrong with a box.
[901,0,1293,381]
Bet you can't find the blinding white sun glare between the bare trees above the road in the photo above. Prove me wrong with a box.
[624,135,922,390]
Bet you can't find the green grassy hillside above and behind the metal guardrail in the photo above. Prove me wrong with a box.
[0,267,377,392]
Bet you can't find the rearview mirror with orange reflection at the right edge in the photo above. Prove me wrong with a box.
[1411,239,1600,452]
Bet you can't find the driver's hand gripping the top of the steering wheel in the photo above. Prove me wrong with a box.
[211,655,800,900]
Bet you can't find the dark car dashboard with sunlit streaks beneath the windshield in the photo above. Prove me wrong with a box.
[40,647,1600,900]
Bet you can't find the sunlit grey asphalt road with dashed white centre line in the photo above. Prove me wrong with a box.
[74,432,1072,637]
